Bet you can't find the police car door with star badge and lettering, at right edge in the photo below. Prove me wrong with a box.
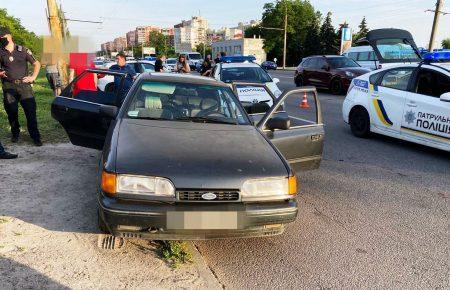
[402,66,450,148]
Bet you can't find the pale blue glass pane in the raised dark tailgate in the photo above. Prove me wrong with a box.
[376,39,420,62]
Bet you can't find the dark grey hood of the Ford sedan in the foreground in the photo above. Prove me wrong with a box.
[116,119,288,190]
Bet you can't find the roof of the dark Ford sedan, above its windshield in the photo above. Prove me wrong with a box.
[140,73,229,88]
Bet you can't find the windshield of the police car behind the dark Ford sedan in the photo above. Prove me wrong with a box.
[220,67,272,83]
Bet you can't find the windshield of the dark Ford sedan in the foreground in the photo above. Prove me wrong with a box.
[127,80,250,125]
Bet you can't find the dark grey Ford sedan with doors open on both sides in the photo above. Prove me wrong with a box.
[52,70,324,240]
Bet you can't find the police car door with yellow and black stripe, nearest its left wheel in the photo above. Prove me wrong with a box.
[369,67,414,135]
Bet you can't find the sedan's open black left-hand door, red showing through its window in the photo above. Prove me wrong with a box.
[52,70,125,150]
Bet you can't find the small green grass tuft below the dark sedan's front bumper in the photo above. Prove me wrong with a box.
[160,241,192,268]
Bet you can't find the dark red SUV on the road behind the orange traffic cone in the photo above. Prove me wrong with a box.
[294,55,370,95]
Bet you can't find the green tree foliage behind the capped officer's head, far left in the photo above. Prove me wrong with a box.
[0,8,43,58]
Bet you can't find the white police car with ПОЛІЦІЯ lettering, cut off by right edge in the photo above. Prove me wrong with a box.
[342,52,450,151]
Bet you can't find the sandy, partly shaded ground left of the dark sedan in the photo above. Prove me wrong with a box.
[0,144,222,289]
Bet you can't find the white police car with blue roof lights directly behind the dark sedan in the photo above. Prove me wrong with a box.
[211,56,282,107]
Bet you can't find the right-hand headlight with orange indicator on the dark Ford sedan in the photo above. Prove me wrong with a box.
[241,176,297,201]
